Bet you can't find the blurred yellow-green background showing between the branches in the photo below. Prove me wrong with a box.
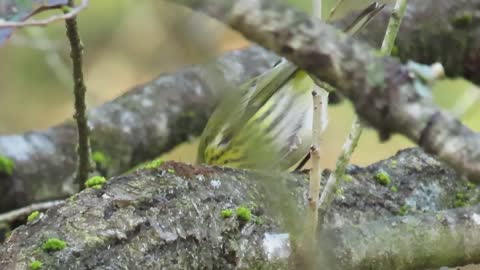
[0,0,480,167]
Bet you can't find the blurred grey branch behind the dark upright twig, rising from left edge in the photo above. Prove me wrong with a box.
[0,47,277,212]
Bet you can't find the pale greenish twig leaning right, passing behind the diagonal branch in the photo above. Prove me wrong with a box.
[318,0,407,226]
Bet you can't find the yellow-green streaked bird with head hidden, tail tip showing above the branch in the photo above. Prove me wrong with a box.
[197,2,384,170]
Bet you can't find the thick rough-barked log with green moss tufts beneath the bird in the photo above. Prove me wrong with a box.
[0,149,480,269]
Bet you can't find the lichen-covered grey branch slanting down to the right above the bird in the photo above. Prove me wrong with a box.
[168,0,480,181]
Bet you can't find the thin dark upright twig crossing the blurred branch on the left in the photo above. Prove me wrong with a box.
[65,0,90,189]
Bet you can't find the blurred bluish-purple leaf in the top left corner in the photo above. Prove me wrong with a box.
[0,0,68,46]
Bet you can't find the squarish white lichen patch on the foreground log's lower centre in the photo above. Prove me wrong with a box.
[263,233,291,260]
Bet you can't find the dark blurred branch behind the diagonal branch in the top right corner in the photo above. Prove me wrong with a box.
[337,0,480,84]
